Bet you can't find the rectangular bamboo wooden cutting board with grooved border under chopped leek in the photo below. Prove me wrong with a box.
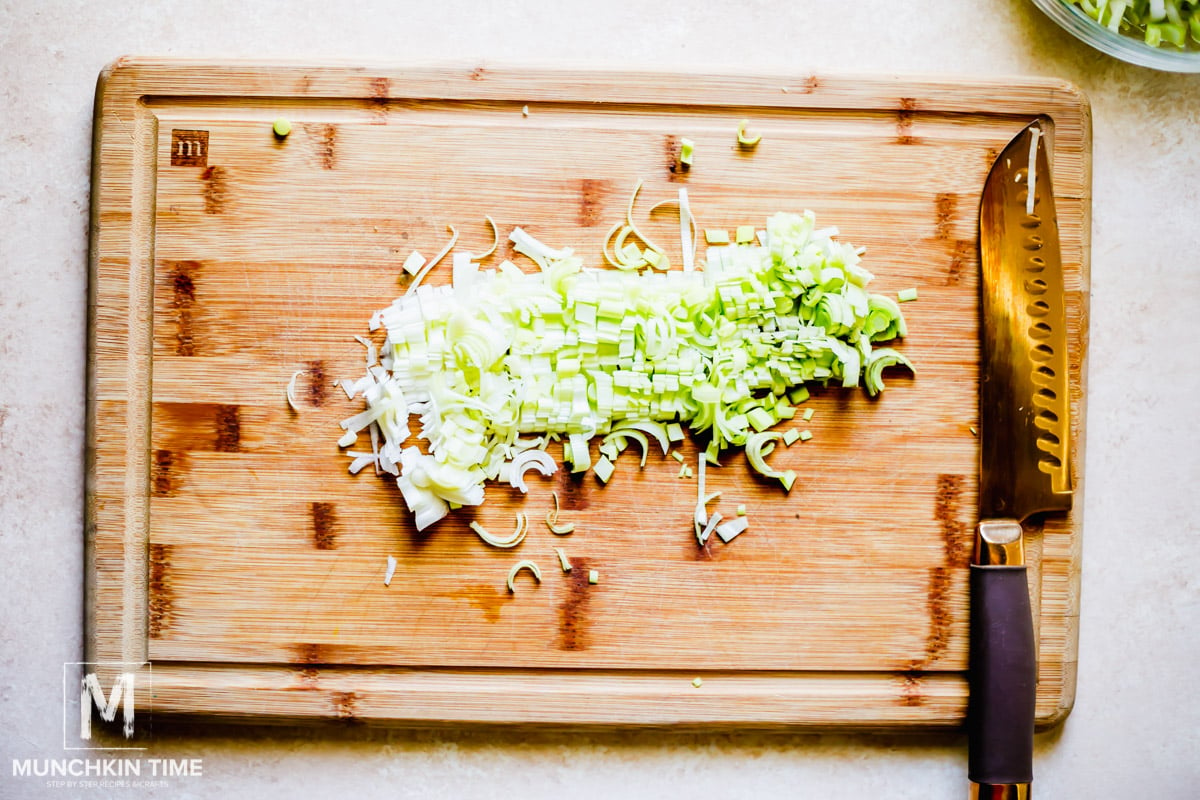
[88,60,1091,728]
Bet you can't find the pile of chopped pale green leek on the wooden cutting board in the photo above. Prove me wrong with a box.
[338,201,910,532]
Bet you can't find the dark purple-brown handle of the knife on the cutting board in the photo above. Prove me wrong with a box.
[967,564,1037,800]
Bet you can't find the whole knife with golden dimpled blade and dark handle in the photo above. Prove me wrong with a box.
[967,121,1072,800]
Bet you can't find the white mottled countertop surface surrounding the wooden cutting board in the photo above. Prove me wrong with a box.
[0,0,1200,800]
